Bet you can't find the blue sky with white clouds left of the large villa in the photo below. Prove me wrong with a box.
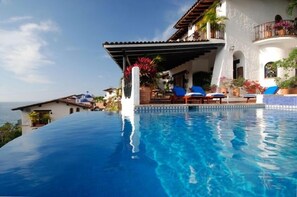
[0,0,196,102]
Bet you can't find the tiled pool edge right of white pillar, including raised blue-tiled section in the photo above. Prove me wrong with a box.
[135,95,297,113]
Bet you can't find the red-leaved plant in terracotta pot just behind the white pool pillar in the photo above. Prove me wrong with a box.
[124,56,161,104]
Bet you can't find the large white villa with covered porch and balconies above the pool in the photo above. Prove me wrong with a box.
[103,0,297,113]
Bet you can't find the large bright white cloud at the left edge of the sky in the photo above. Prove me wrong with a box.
[0,21,58,83]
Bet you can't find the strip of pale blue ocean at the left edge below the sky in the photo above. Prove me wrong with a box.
[0,102,33,126]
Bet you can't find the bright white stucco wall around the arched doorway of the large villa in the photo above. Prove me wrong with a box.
[212,0,296,85]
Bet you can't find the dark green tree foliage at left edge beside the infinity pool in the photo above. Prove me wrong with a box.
[0,122,22,147]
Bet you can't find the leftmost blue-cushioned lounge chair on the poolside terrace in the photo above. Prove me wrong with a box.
[171,86,204,104]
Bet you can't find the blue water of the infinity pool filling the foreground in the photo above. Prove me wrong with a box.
[0,109,297,196]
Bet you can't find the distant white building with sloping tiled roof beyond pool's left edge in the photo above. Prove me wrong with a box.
[12,94,93,134]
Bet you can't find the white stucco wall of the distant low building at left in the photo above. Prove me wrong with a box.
[21,102,89,134]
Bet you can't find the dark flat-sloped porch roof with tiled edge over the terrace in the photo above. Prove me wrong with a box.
[103,40,224,70]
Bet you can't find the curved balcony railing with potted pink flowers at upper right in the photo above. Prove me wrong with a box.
[254,20,297,41]
